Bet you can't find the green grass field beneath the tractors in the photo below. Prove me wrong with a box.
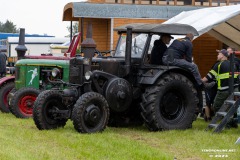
[0,113,240,160]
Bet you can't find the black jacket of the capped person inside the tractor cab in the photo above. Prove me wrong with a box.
[150,40,167,65]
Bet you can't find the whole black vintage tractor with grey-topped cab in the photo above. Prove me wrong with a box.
[33,24,202,133]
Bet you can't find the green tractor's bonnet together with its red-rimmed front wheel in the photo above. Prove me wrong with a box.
[9,59,69,118]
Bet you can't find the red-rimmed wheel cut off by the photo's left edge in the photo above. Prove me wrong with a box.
[0,82,14,113]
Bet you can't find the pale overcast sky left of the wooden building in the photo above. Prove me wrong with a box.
[0,0,85,37]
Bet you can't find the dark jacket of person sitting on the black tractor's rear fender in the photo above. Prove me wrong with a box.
[164,37,193,63]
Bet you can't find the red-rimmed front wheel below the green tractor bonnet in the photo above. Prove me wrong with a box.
[10,88,40,118]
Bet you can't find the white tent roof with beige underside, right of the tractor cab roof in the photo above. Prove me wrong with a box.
[164,5,240,50]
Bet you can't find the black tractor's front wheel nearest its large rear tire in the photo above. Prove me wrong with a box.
[72,92,109,133]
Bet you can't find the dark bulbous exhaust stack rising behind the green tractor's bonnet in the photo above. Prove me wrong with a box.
[15,28,27,60]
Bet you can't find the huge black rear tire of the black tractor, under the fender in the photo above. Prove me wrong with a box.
[141,73,198,131]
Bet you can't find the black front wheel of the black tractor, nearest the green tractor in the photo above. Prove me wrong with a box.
[33,90,68,130]
